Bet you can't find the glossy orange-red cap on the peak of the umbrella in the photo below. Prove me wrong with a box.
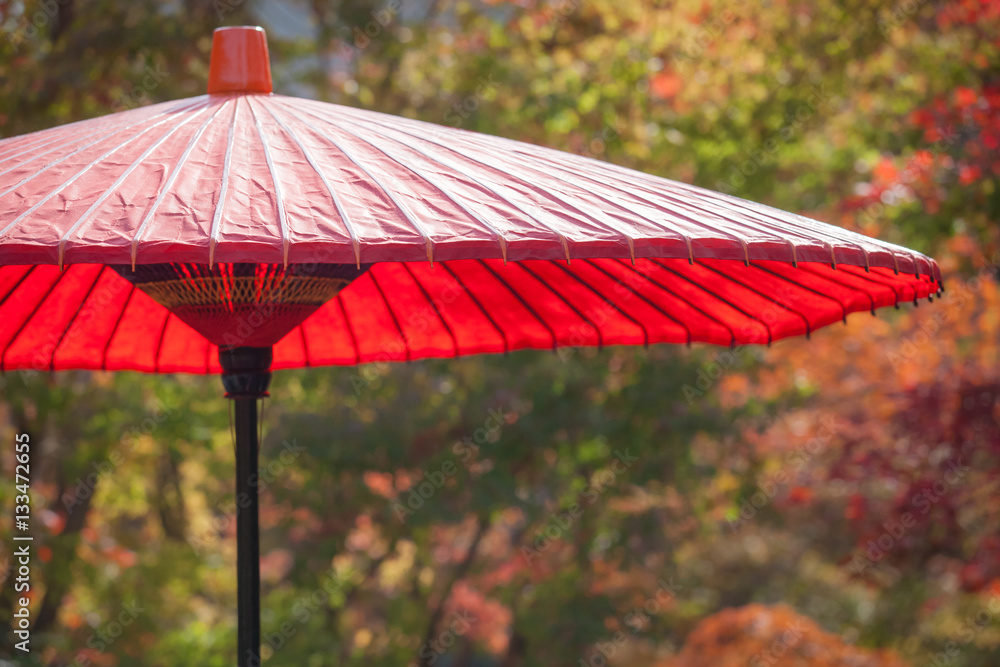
[208,26,272,95]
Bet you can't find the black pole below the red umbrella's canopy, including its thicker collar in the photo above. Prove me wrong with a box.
[219,347,272,667]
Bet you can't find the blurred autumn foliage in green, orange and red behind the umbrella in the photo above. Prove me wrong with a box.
[0,0,1000,667]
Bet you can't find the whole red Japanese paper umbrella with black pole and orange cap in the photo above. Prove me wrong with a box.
[0,27,941,665]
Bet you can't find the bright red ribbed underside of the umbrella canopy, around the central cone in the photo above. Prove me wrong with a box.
[0,258,939,373]
